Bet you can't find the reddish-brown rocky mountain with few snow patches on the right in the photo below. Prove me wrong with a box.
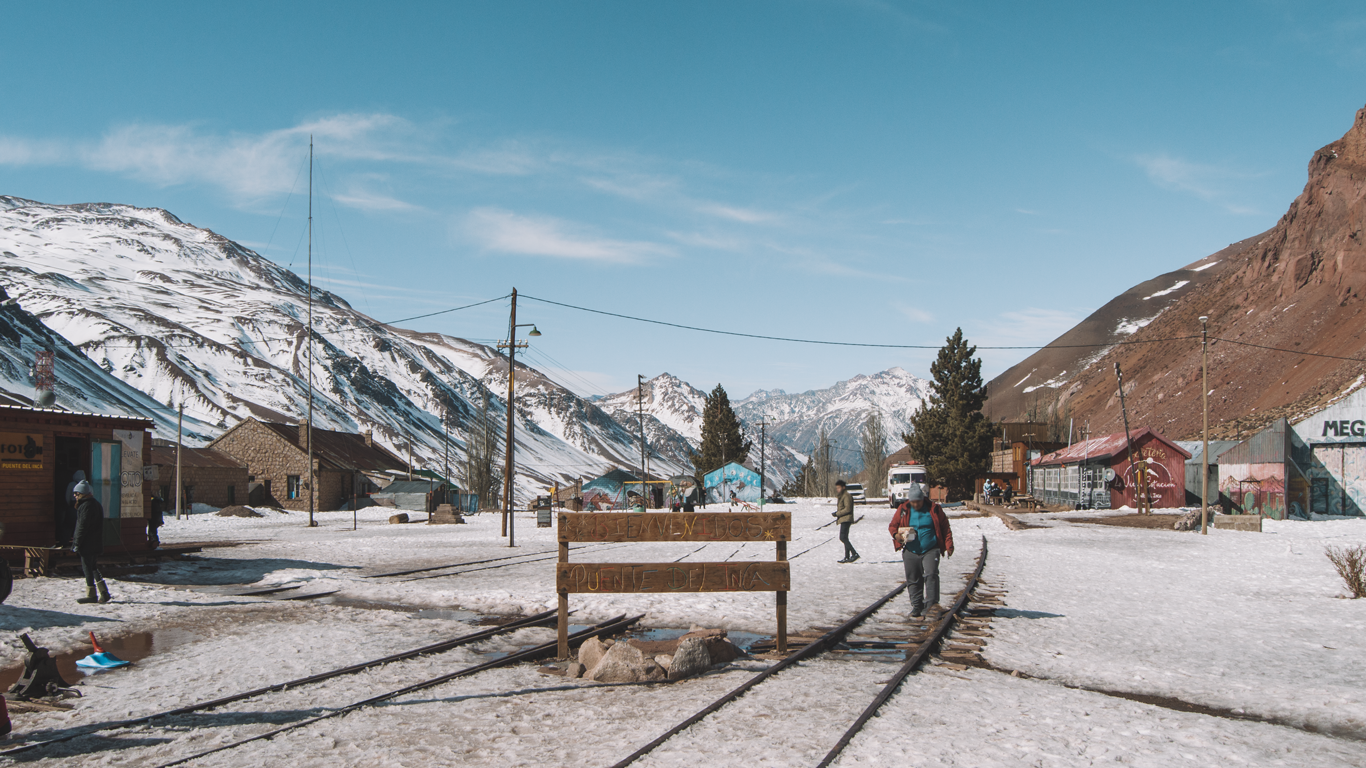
[990,102,1366,439]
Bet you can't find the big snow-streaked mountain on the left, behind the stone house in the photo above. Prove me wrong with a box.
[0,197,683,495]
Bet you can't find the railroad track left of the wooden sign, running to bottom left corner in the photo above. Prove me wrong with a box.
[0,611,642,765]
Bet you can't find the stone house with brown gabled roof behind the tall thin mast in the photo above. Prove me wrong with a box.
[209,418,408,511]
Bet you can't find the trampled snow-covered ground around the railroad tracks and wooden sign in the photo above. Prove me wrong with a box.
[0,500,1366,767]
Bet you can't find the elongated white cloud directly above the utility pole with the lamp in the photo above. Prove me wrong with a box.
[464,208,668,264]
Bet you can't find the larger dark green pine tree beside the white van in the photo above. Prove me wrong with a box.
[902,328,992,499]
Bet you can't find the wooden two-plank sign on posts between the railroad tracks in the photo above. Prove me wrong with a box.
[555,512,792,659]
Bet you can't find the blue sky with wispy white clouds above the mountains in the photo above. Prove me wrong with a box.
[0,0,1366,398]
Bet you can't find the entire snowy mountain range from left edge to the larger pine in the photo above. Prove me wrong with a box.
[0,197,928,496]
